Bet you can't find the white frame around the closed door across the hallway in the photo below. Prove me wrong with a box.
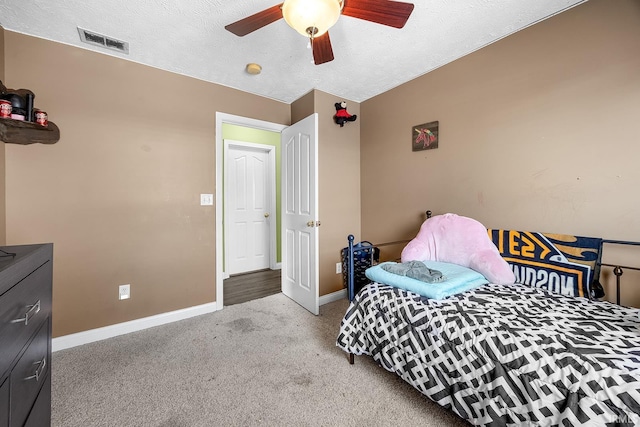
[223,139,278,278]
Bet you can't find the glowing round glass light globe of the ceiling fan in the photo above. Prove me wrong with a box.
[282,0,342,37]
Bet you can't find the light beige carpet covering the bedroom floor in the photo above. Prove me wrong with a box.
[52,294,468,427]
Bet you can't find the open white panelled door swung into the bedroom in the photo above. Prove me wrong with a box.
[281,114,320,315]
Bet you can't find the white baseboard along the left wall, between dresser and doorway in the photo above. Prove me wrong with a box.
[51,302,218,351]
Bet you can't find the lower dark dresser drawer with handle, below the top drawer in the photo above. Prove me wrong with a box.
[10,321,51,427]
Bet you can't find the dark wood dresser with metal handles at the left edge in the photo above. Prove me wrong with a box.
[0,243,53,427]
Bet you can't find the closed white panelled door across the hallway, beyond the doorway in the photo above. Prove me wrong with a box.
[225,141,275,274]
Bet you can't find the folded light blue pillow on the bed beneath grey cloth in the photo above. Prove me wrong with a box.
[365,261,489,299]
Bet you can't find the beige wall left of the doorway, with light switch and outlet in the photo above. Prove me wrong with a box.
[5,31,290,336]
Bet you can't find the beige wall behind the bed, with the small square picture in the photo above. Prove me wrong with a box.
[360,0,640,304]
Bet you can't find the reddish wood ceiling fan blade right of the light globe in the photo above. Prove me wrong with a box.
[342,0,413,28]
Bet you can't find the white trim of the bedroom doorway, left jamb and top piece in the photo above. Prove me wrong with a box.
[215,111,287,310]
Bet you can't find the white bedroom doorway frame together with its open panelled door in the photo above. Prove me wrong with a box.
[215,112,320,315]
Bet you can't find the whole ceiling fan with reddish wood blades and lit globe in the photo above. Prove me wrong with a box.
[224,0,413,65]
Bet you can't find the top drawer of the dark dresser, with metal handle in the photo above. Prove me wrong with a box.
[0,262,52,375]
